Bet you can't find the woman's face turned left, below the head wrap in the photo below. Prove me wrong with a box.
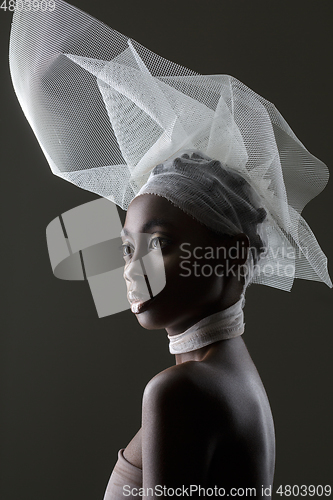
[122,194,241,335]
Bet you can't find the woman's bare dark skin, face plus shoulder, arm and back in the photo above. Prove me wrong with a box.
[123,195,275,498]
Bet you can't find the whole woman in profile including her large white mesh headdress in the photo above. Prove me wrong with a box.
[10,0,332,499]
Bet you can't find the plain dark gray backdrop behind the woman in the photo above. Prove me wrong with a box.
[0,0,333,500]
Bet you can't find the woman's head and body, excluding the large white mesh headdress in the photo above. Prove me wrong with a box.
[105,153,275,500]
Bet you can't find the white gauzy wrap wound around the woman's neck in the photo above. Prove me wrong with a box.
[168,295,245,354]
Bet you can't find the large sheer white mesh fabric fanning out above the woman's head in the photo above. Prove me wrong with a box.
[10,0,332,290]
